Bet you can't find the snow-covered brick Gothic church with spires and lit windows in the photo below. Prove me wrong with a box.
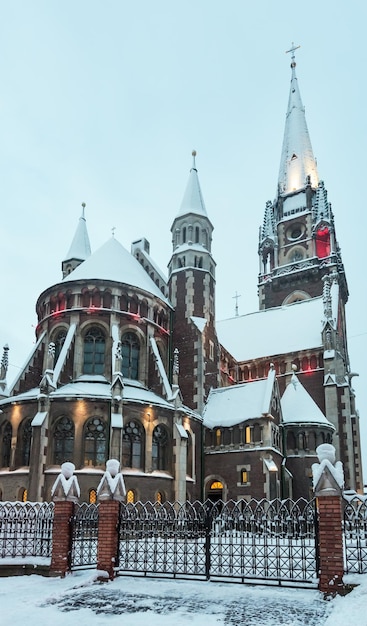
[0,48,363,502]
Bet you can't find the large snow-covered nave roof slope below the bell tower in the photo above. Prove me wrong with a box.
[216,297,323,361]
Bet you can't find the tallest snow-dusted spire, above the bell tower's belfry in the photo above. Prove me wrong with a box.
[278,44,319,194]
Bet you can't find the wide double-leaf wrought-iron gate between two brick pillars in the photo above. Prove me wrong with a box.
[117,499,318,584]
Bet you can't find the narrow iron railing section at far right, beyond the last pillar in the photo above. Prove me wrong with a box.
[344,496,367,574]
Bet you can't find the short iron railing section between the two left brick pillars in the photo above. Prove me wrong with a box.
[71,503,98,569]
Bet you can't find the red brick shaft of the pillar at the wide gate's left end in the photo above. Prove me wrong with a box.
[97,500,120,580]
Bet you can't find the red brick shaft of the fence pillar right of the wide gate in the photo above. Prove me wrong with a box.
[317,495,344,595]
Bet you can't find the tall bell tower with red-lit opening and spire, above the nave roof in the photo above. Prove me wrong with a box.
[258,45,348,309]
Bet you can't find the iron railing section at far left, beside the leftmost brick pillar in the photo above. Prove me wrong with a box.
[0,502,54,558]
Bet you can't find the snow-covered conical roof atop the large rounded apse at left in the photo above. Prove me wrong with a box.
[62,237,169,304]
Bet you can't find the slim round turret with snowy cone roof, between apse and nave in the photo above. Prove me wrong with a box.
[168,151,219,412]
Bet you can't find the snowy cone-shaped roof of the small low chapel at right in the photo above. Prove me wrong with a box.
[280,374,332,426]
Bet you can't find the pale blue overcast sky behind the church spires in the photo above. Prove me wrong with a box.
[0,0,367,472]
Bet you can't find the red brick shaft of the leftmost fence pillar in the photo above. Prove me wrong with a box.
[50,500,74,576]
